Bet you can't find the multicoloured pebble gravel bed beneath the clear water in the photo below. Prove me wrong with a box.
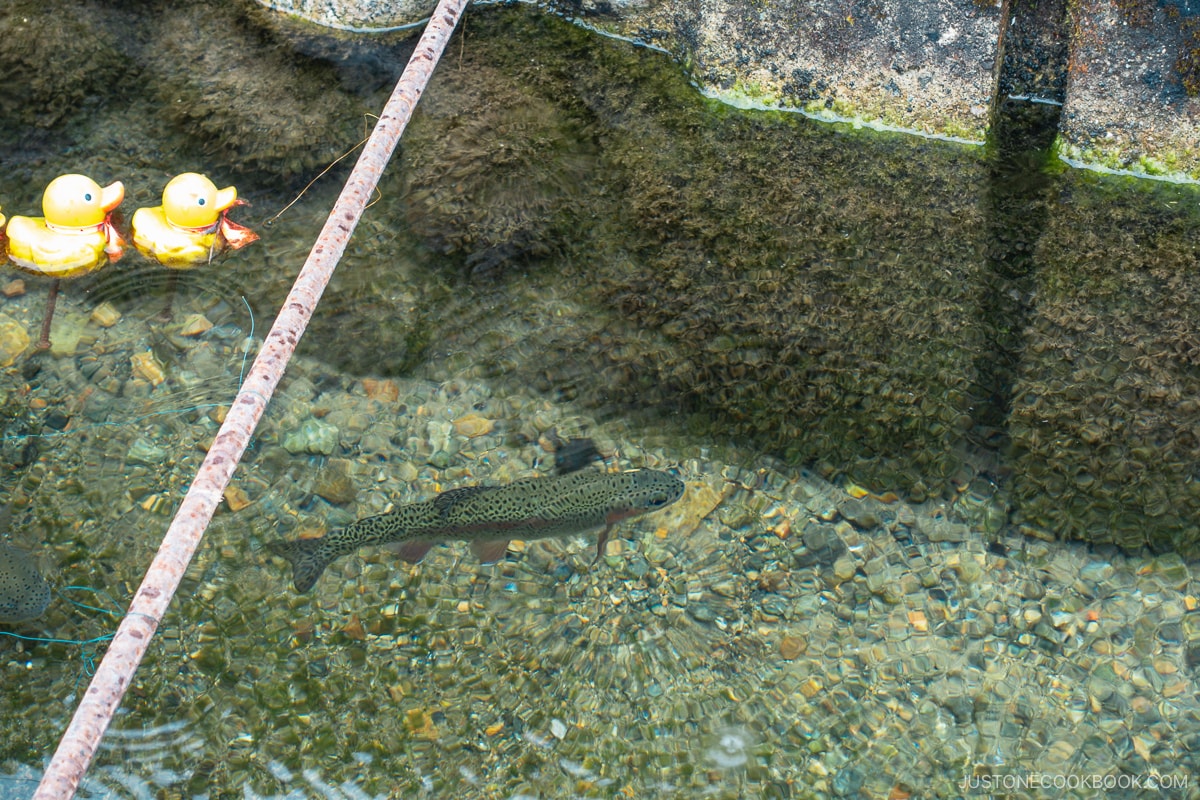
[0,278,1200,798]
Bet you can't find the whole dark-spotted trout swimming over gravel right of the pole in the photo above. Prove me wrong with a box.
[266,469,683,591]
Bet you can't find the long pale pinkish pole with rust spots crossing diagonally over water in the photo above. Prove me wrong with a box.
[34,0,467,800]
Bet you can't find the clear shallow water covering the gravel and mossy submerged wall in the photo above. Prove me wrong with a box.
[0,0,1200,798]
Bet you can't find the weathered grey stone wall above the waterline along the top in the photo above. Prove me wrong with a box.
[259,0,1200,179]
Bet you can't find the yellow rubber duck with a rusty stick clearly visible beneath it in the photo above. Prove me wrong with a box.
[5,174,125,350]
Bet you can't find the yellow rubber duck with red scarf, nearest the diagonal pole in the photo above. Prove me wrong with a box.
[132,173,258,270]
